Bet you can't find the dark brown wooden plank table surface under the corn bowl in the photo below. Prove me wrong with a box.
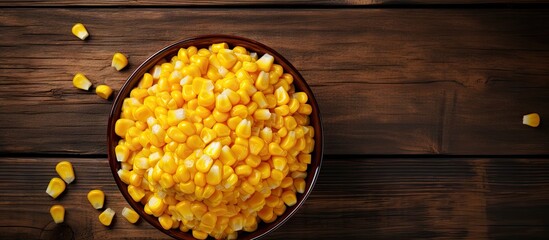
[0,0,549,239]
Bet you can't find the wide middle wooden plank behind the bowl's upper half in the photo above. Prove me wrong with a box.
[0,8,549,155]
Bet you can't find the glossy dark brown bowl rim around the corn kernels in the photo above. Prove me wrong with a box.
[107,35,323,239]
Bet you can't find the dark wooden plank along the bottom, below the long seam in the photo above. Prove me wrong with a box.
[0,157,549,239]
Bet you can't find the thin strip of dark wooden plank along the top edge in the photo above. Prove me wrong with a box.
[0,0,548,7]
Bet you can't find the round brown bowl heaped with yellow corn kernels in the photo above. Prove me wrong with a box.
[108,35,323,239]
